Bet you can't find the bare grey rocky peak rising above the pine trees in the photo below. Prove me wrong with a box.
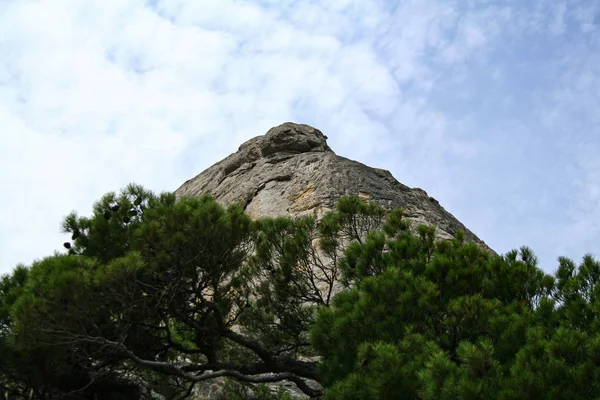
[175,122,488,248]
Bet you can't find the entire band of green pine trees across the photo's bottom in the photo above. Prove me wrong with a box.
[0,184,600,400]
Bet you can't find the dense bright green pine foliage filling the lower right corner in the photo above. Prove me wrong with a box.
[311,205,600,399]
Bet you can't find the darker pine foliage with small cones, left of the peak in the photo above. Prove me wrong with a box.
[0,185,252,398]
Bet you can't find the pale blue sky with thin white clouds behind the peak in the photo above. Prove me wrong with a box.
[0,0,600,273]
